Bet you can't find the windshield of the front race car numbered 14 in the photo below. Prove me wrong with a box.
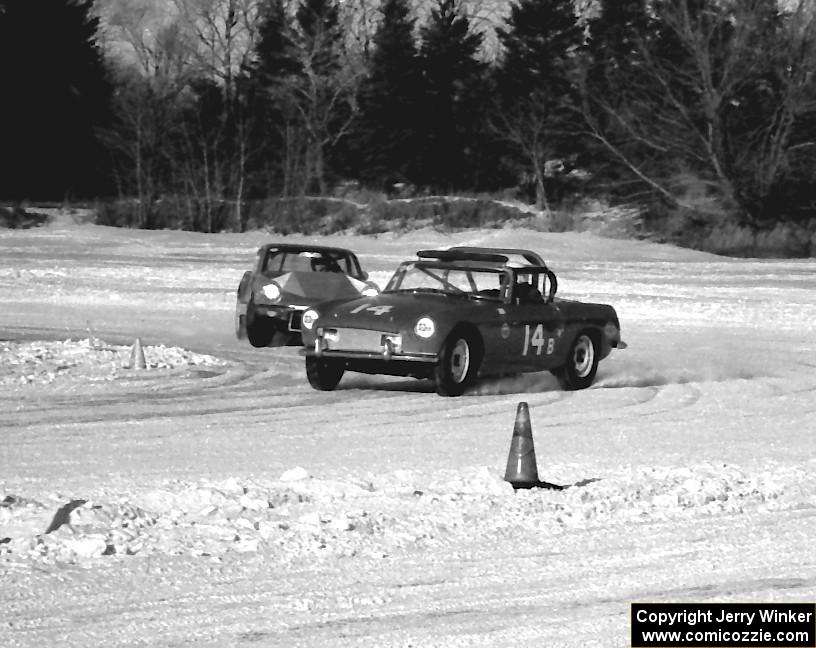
[385,262,505,301]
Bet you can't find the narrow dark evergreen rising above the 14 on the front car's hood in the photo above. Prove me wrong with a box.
[355,0,420,187]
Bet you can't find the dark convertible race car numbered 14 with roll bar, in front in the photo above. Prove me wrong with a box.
[303,247,626,396]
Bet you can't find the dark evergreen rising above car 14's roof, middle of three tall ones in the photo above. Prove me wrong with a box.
[417,0,486,189]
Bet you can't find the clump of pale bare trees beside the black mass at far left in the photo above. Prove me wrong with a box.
[99,0,259,230]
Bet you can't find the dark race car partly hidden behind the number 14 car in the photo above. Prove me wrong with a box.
[235,243,379,347]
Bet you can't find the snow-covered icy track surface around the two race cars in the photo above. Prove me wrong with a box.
[0,219,816,647]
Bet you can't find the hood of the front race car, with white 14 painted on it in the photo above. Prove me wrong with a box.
[318,292,484,331]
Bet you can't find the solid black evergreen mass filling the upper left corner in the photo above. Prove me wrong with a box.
[0,0,111,200]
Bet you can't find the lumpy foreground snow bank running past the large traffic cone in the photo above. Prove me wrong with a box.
[0,462,816,565]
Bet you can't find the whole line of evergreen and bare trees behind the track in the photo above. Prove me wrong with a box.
[0,0,816,231]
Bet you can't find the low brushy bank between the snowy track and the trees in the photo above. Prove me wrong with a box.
[89,190,816,257]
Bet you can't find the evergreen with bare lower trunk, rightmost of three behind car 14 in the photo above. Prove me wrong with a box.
[494,0,582,208]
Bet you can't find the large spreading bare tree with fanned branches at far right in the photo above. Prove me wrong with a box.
[583,0,816,225]
